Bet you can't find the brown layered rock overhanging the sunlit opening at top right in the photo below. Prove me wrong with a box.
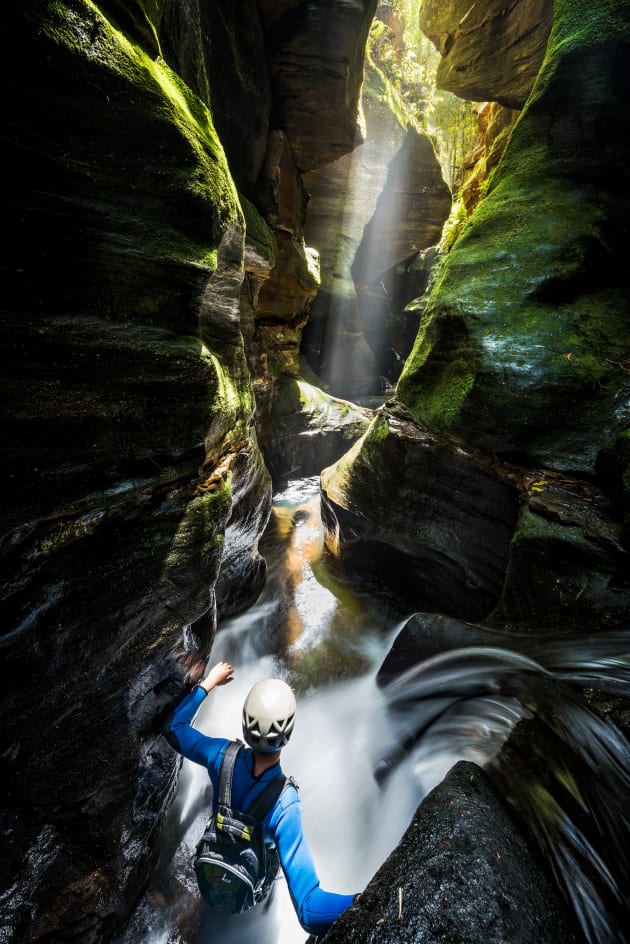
[420,0,553,109]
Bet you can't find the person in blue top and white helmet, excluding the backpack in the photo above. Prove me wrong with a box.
[164,662,358,941]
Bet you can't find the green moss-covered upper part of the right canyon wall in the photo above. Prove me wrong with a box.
[397,0,630,471]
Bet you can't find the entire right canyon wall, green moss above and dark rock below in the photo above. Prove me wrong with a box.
[322,0,630,632]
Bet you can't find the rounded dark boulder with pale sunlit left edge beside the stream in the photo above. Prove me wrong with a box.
[322,401,517,620]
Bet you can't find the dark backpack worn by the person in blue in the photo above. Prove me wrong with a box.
[193,741,287,914]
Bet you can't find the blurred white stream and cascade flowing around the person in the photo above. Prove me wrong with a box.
[117,478,630,944]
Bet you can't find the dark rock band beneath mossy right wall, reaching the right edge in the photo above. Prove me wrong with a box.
[322,400,630,638]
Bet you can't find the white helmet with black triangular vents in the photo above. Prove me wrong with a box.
[243,679,295,754]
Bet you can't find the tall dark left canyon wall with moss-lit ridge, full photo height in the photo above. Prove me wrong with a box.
[0,0,270,942]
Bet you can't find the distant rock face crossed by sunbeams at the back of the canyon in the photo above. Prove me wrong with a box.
[304,70,451,398]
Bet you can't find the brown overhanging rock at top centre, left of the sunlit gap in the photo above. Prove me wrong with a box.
[258,0,377,172]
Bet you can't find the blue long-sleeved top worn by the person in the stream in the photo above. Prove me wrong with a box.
[164,686,354,934]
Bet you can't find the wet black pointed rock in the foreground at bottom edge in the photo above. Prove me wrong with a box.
[324,762,579,944]
